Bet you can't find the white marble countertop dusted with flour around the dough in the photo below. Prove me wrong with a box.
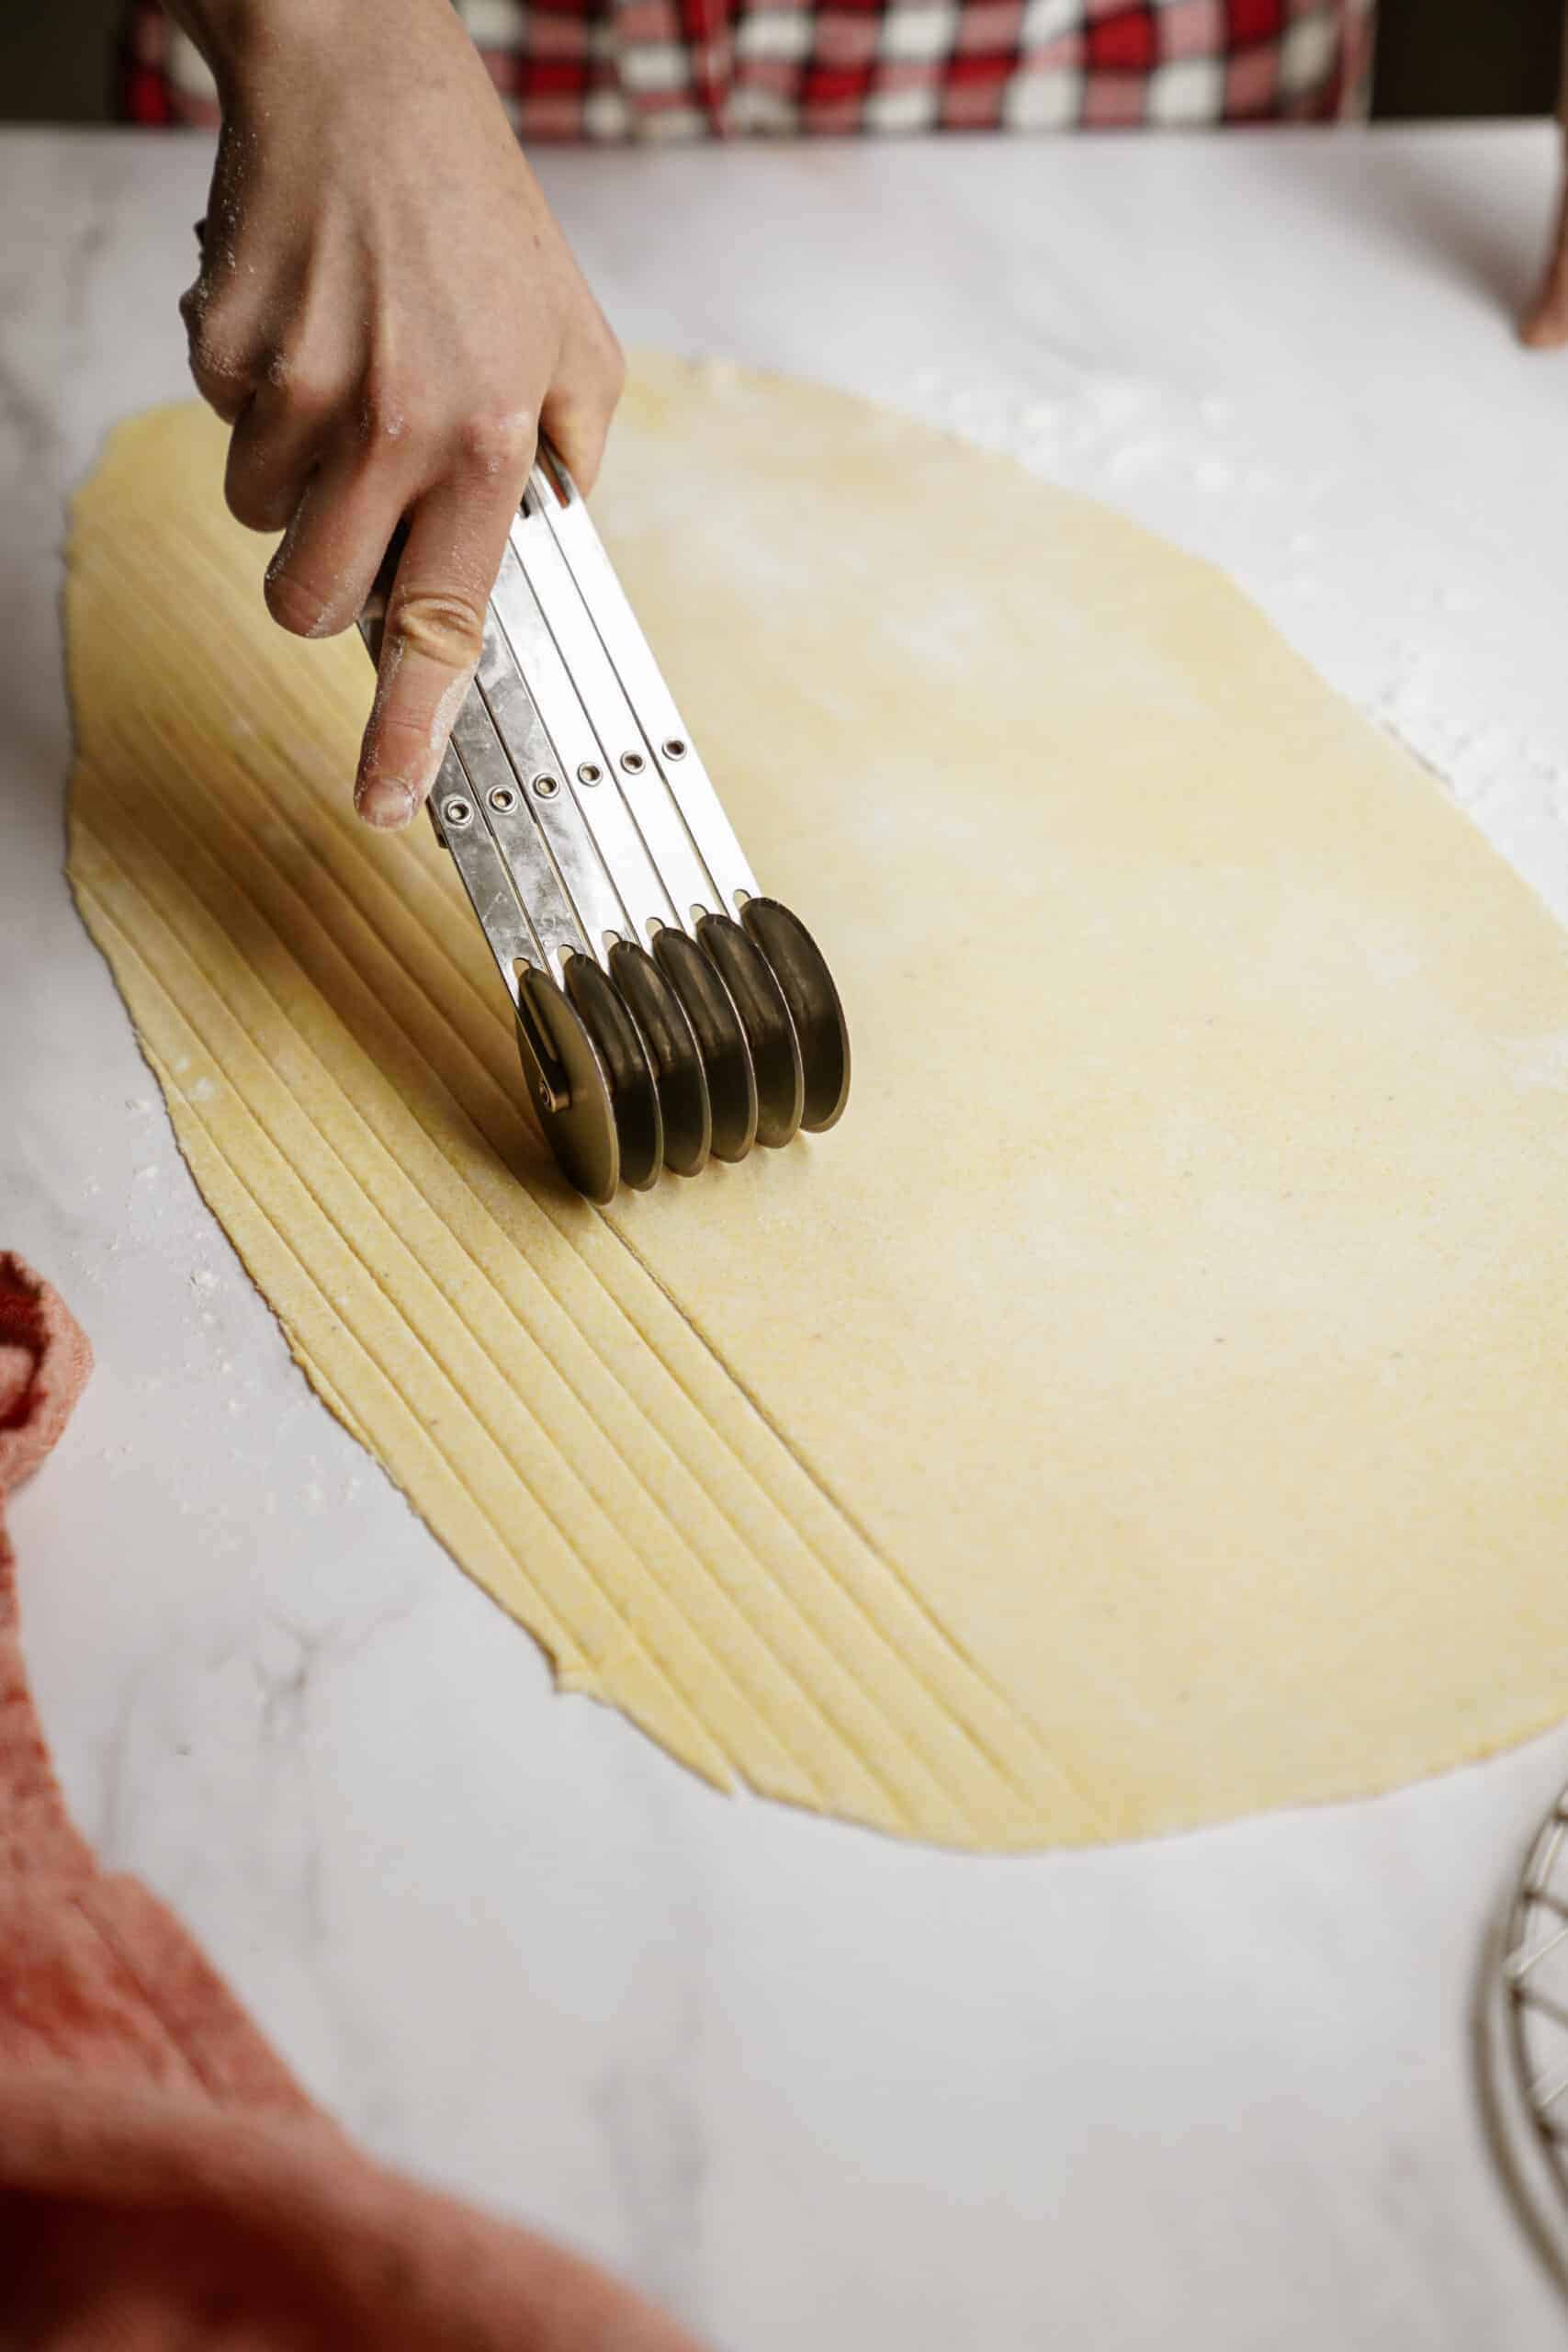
[0,127,1568,2352]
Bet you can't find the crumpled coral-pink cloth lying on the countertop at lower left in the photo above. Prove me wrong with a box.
[0,1253,696,2352]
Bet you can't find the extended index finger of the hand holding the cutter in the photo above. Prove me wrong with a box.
[355,465,517,828]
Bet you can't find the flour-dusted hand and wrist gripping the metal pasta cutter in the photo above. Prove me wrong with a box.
[172,0,623,826]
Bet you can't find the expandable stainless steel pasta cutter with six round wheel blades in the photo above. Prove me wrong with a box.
[365,445,849,1202]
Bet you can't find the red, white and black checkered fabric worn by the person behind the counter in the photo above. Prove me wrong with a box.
[120,0,1375,141]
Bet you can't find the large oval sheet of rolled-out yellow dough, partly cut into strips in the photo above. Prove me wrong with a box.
[68,357,1568,1847]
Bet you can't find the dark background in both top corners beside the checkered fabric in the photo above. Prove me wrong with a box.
[0,0,1565,122]
